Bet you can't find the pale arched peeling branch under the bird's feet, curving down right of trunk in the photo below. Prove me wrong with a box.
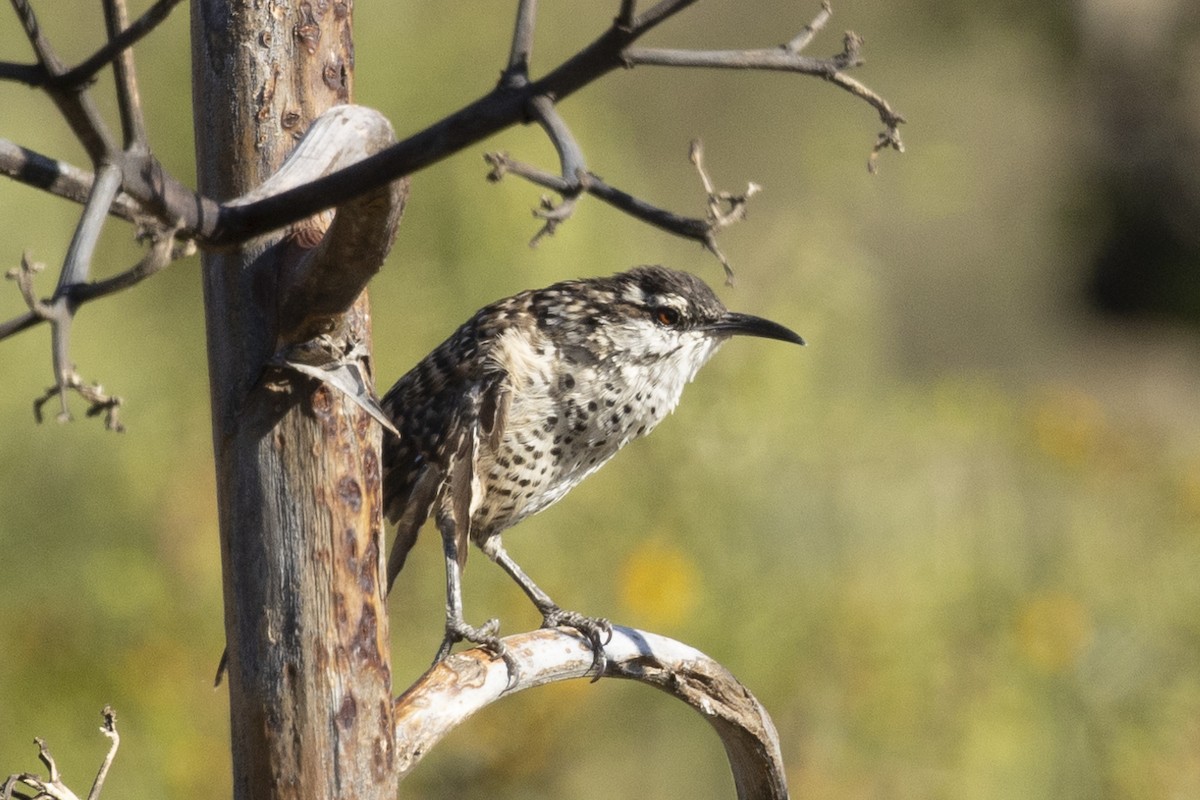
[395,626,787,800]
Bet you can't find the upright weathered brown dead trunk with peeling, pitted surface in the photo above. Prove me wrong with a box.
[192,0,396,800]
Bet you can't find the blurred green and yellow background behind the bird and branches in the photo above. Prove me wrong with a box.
[0,0,1200,800]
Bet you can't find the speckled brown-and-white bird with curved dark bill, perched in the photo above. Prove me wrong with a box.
[382,266,804,676]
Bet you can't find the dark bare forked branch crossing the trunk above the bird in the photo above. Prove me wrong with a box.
[0,0,904,326]
